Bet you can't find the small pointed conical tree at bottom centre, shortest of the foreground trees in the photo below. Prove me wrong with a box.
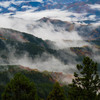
[47,83,66,100]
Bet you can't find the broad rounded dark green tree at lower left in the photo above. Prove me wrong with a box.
[2,73,37,100]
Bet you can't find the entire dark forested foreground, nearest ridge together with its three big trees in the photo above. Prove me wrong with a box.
[0,57,100,100]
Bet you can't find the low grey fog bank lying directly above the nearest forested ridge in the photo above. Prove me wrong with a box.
[9,53,76,74]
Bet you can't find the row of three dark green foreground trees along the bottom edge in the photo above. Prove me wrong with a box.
[2,57,100,100]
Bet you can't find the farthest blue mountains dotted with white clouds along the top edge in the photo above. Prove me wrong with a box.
[0,0,100,24]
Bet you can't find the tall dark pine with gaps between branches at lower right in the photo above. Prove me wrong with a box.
[68,57,100,100]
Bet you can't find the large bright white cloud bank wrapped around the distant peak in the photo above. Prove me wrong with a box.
[0,10,88,49]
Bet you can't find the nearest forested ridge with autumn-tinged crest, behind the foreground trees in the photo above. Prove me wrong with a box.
[0,65,71,100]
